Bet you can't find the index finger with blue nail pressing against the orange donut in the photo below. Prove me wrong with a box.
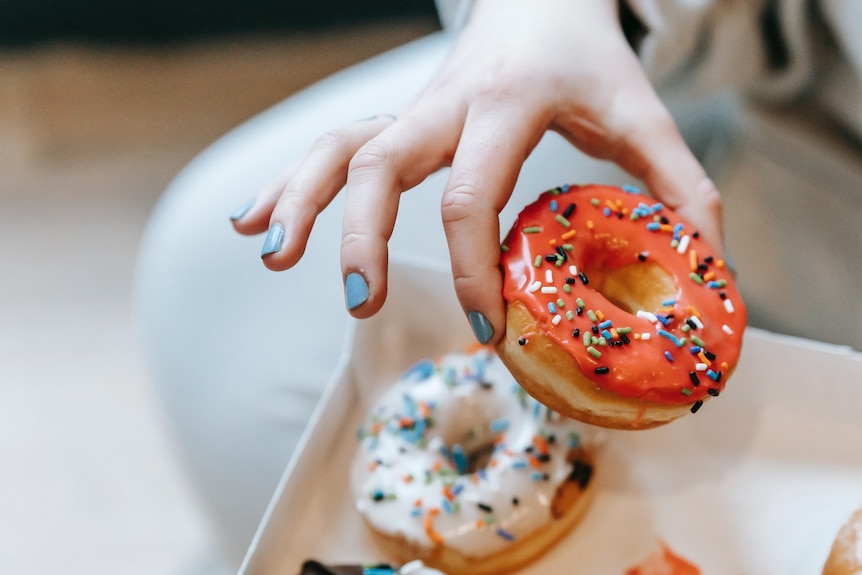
[441,106,547,344]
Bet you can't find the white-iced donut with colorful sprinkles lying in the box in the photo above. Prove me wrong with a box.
[353,347,593,575]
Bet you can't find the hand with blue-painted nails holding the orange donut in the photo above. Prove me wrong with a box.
[234,0,722,343]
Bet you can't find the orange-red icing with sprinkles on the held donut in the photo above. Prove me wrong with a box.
[503,186,745,412]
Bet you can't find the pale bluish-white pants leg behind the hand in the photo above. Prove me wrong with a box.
[135,30,859,568]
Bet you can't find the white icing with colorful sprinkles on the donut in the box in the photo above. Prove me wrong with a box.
[357,348,592,556]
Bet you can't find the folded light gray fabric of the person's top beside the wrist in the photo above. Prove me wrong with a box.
[436,0,862,140]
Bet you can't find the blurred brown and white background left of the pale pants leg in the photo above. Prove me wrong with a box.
[0,0,439,575]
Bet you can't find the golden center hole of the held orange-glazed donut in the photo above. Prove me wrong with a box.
[590,262,677,314]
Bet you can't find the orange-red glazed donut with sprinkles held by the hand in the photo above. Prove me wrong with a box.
[497,185,746,429]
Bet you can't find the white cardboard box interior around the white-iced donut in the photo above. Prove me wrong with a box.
[240,264,862,575]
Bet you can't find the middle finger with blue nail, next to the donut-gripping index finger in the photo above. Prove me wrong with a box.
[341,100,470,318]
